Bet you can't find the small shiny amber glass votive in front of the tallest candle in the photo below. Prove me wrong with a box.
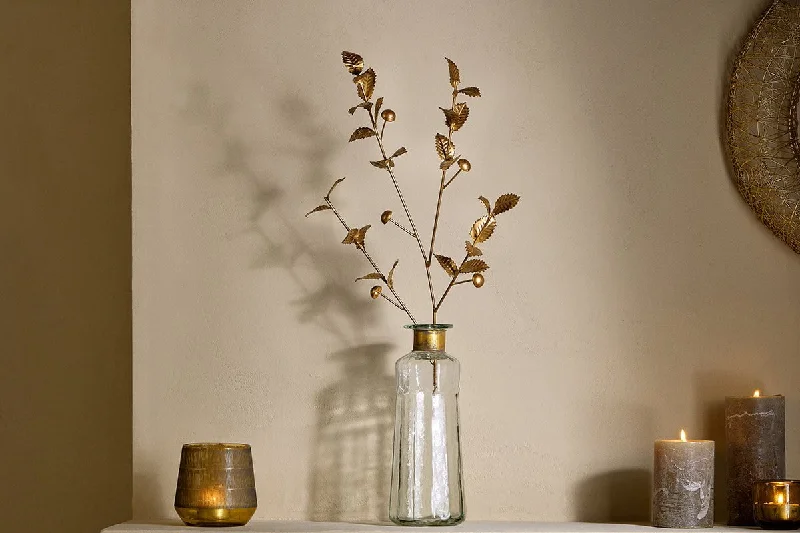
[753,480,800,529]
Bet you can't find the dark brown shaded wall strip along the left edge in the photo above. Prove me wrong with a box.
[0,0,131,533]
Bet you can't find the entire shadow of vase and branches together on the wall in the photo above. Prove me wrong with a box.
[180,85,394,523]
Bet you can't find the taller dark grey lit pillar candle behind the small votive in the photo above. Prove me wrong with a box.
[725,390,786,526]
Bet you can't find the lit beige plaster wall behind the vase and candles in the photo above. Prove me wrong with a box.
[132,0,800,520]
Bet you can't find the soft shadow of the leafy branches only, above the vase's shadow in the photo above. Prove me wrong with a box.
[189,87,375,346]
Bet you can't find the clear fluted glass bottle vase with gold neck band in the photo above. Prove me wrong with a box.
[389,324,464,526]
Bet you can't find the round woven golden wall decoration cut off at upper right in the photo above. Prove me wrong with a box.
[726,0,800,253]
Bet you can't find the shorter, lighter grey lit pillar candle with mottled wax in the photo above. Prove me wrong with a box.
[653,432,714,529]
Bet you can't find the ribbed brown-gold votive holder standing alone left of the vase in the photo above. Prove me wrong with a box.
[175,443,256,526]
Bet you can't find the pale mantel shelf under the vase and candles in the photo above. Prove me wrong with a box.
[103,520,758,533]
